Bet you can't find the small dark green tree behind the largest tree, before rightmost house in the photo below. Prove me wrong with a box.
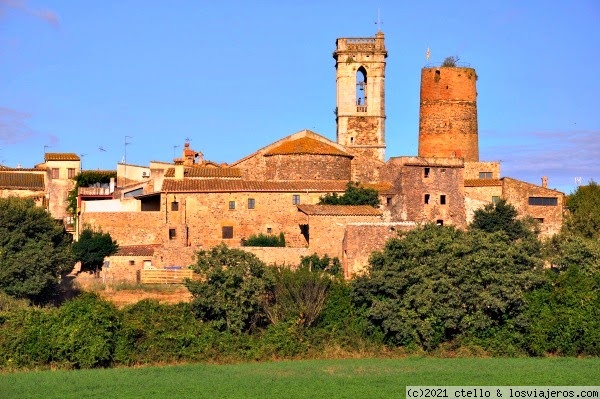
[470,199,537,240]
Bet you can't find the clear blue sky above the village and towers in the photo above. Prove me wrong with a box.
[0,0,600,193]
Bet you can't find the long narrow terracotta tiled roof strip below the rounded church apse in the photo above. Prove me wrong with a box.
[162,179,347,193]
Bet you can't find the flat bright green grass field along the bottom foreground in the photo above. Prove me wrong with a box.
[0,357,600,399]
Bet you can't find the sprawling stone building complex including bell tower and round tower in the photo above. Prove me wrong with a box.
[68,32,564,277]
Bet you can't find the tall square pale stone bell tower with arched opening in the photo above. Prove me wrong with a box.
[333,31,387,161]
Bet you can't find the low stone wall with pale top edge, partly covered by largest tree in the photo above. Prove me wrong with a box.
[342,222,416,278]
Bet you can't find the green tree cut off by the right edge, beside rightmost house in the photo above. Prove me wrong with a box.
[565,180,600,239]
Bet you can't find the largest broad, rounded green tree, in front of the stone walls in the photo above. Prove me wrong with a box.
[353,224,541,349]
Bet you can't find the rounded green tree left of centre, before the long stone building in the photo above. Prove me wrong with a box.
[185,244,273,333]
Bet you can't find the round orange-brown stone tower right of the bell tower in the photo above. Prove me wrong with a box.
[419,67,479,162]
